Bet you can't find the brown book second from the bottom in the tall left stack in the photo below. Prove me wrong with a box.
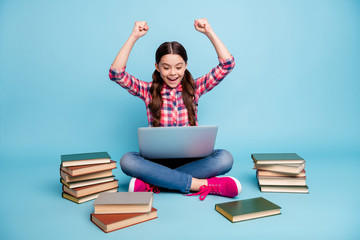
[63,180,118,198]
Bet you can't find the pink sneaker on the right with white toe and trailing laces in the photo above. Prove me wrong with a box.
[188,177,242,200]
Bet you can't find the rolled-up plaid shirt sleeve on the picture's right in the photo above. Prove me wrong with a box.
[195,56,235,97]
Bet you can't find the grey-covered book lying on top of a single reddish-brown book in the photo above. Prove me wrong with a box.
[93,192,153,214]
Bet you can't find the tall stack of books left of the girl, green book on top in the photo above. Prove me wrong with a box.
[60,152,118,203]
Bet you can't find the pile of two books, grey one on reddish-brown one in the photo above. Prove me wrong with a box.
[90,192,157,233]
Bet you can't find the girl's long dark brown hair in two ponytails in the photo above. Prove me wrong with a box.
[149,41,196,127]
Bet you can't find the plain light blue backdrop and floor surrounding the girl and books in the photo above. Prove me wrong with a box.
[0,0,360,239]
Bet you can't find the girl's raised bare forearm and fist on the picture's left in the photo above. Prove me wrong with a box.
[111,21,149,69]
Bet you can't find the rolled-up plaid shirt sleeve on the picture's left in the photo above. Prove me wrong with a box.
[109,67,150,101]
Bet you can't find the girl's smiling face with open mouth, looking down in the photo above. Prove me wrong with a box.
[155,54,187,88]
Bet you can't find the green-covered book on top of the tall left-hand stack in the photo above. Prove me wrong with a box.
[61,152,111,167]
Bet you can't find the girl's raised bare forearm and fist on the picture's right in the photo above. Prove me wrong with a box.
[194,18,232,59]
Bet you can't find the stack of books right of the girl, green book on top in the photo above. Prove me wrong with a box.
[251,153,309,193]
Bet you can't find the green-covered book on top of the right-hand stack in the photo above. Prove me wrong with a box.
[251,153,304,164]
